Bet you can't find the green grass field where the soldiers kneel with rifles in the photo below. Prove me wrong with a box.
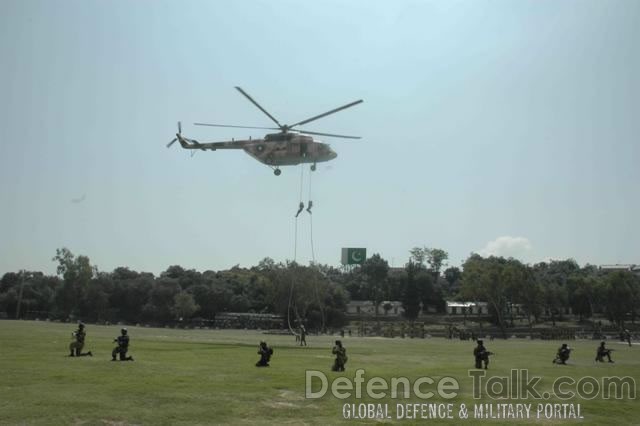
[0,321,640,425]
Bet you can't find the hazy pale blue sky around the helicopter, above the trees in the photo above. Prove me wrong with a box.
[0,0,640,274]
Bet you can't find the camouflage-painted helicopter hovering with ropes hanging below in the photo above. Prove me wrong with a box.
[167,86,363,176]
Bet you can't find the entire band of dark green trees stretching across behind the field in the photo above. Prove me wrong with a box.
[0,247,640,331]
